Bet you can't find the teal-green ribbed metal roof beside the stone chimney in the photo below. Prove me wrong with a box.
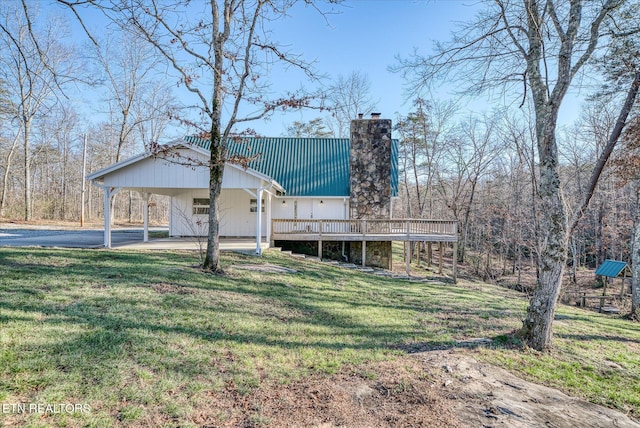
[185,136,398,197]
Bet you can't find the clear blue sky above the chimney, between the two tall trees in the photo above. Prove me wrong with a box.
[250,0,475,135]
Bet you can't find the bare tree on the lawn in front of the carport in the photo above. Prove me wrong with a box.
[64,0,330,271]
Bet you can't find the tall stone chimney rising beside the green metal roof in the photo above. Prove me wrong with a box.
[349,113,391,219]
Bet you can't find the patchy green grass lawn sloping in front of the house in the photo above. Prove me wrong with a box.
[0,248,640,427]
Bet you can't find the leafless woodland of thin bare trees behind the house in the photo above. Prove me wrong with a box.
[0,2,639,290]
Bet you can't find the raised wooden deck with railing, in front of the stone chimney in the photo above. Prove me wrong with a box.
[271,219,458,242]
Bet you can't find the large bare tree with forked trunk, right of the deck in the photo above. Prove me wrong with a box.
[398,0,635,350]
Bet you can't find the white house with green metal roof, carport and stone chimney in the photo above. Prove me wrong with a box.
[87,116,454,267]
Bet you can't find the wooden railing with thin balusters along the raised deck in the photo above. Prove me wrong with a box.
[272,219,458,239]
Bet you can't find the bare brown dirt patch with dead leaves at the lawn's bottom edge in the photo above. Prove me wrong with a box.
[182,350,640,428]
